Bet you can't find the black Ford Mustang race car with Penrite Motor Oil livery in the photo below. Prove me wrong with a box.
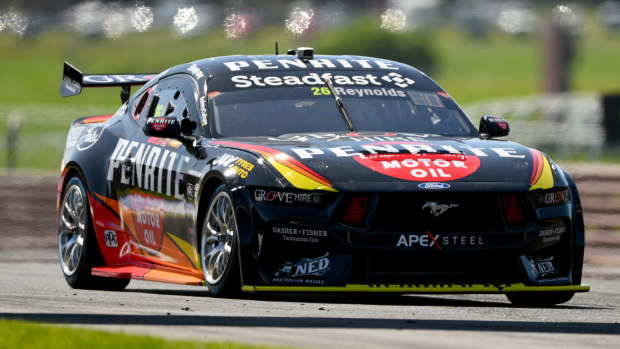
[58,48,589,305]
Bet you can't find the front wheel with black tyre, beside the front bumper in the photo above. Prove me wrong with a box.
[200,185,241,297]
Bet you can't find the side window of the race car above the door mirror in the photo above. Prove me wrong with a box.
[143,75,201,137]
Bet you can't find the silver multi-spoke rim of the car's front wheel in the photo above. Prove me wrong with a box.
[200,192,237,284]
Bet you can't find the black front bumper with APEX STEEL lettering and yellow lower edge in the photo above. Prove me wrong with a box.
[242,188,589,293]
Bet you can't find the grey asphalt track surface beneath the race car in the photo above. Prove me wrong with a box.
[0,248,620,349]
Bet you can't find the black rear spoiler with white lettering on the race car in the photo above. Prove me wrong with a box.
[60,62,157,103]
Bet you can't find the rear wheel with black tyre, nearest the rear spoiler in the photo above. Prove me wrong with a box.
[58,176,130,291]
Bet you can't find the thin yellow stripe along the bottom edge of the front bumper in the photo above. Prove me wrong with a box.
[242,282,590,293]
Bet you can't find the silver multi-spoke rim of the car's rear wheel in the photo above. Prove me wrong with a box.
[58,184,87,275]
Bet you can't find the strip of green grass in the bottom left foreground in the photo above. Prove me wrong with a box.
[0,319,286,349]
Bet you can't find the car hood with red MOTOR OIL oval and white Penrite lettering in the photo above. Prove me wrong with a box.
[211,133,554,191]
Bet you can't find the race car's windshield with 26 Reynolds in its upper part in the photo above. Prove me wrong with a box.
[208,72,475,137]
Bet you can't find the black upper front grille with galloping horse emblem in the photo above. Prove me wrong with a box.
[370,193,504,232]
